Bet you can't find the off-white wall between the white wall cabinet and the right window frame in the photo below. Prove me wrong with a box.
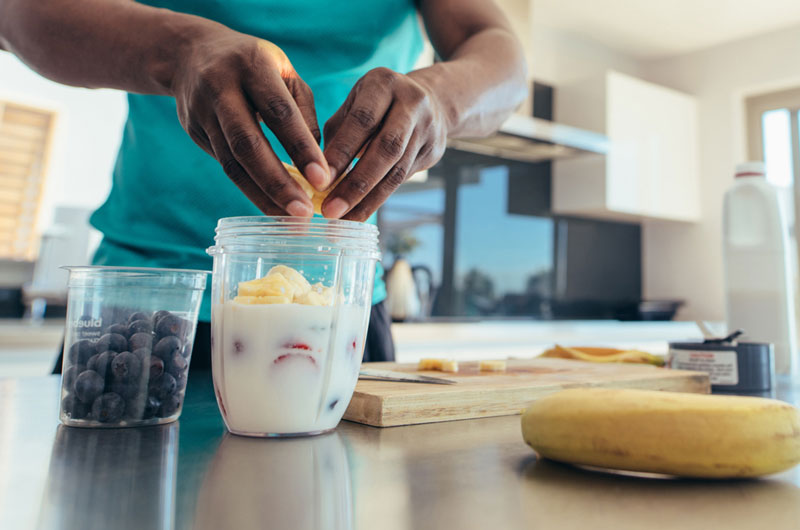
[643,22,800,320]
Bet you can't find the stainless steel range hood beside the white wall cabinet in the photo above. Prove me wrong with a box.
[447,114,609,162]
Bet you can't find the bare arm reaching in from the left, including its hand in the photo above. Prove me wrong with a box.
[0,0,329,216]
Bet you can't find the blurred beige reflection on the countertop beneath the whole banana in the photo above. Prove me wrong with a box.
[516,457,800,530]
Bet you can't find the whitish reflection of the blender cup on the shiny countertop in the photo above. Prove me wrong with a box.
[195,432,353,530]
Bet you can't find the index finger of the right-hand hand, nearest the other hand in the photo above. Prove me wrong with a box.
[325,68,396,183]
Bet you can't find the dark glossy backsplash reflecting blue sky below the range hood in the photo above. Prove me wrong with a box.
[379,83,642,319]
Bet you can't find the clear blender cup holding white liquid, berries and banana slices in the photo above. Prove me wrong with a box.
[208,213,380,437]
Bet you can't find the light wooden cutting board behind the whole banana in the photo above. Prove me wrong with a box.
[344,358,711,427]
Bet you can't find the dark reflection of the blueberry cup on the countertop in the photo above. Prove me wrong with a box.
[38,423,178,530]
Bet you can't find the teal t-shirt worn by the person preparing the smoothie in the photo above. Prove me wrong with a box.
[91,0,422,320]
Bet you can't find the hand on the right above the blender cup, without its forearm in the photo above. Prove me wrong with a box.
[322,68,448,221]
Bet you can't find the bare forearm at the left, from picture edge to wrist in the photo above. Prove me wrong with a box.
[0,0,215,94]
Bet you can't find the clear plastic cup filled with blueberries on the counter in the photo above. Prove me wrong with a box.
[60,267,208,427]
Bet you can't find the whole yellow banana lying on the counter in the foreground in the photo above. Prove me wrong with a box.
[522,388,800,478]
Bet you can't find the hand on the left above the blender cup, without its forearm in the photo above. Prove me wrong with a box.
[172,26,330,217]
